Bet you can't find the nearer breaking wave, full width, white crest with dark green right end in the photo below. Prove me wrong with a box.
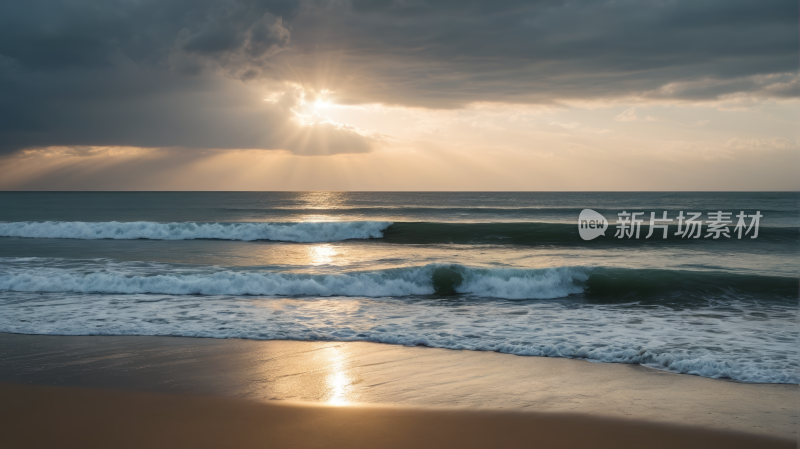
[0,264,798,302]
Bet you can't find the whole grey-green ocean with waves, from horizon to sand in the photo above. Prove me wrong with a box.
[0,192,800,384]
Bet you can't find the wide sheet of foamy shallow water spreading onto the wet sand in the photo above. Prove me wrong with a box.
[0,292,800,384]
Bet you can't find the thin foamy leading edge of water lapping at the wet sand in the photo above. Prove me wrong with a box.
[0,312,800,384]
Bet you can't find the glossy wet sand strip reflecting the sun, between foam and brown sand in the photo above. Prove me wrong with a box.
[0,334,800,440]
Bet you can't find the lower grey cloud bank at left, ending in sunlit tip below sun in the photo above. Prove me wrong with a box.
[0,60,375,156]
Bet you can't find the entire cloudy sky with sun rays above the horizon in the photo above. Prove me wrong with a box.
[0,0,800,191]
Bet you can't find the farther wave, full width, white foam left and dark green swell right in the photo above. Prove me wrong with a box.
[0,221,800,246]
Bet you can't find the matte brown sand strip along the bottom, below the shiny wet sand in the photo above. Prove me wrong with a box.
[0,384,794,449]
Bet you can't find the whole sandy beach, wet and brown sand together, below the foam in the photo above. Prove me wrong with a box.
[0,334,800,447]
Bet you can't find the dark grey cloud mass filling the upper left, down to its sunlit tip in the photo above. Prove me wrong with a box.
[0,0,375,156]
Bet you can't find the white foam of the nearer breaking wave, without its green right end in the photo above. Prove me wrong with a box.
[0,264,587,299]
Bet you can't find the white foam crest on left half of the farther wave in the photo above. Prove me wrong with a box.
[0,221,391,243]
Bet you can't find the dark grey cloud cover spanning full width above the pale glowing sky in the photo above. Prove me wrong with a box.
[0,0,798,155]
